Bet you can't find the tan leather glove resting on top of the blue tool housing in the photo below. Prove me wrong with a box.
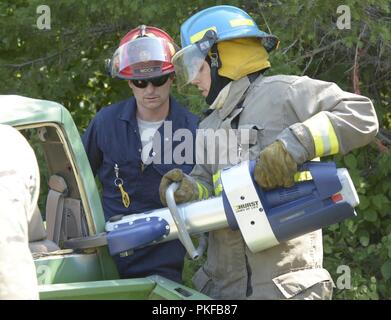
[254,141,297,188]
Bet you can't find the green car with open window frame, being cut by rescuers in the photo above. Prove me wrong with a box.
[0,95,209,300]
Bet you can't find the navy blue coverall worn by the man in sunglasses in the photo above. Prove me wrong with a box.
[82,96,198,282]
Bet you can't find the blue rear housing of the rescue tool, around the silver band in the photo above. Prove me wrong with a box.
[222,161,356,242]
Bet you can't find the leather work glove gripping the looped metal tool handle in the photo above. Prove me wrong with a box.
[159,169,198,206]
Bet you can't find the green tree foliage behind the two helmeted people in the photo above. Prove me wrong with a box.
[0,0,391,299]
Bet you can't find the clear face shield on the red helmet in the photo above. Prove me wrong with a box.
[110,37,176,80]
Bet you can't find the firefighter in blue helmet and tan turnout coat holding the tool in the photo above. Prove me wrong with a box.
[160,6,378,299]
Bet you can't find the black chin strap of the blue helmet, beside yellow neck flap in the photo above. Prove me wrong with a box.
[205,44,232,105]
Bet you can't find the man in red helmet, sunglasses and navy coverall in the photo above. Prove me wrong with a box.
[83,26,198,282]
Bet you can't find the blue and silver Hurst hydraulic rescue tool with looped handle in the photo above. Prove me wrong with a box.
[65,161,359,259]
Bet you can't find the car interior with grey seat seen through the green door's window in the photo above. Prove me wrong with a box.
[21,125,88,256]
